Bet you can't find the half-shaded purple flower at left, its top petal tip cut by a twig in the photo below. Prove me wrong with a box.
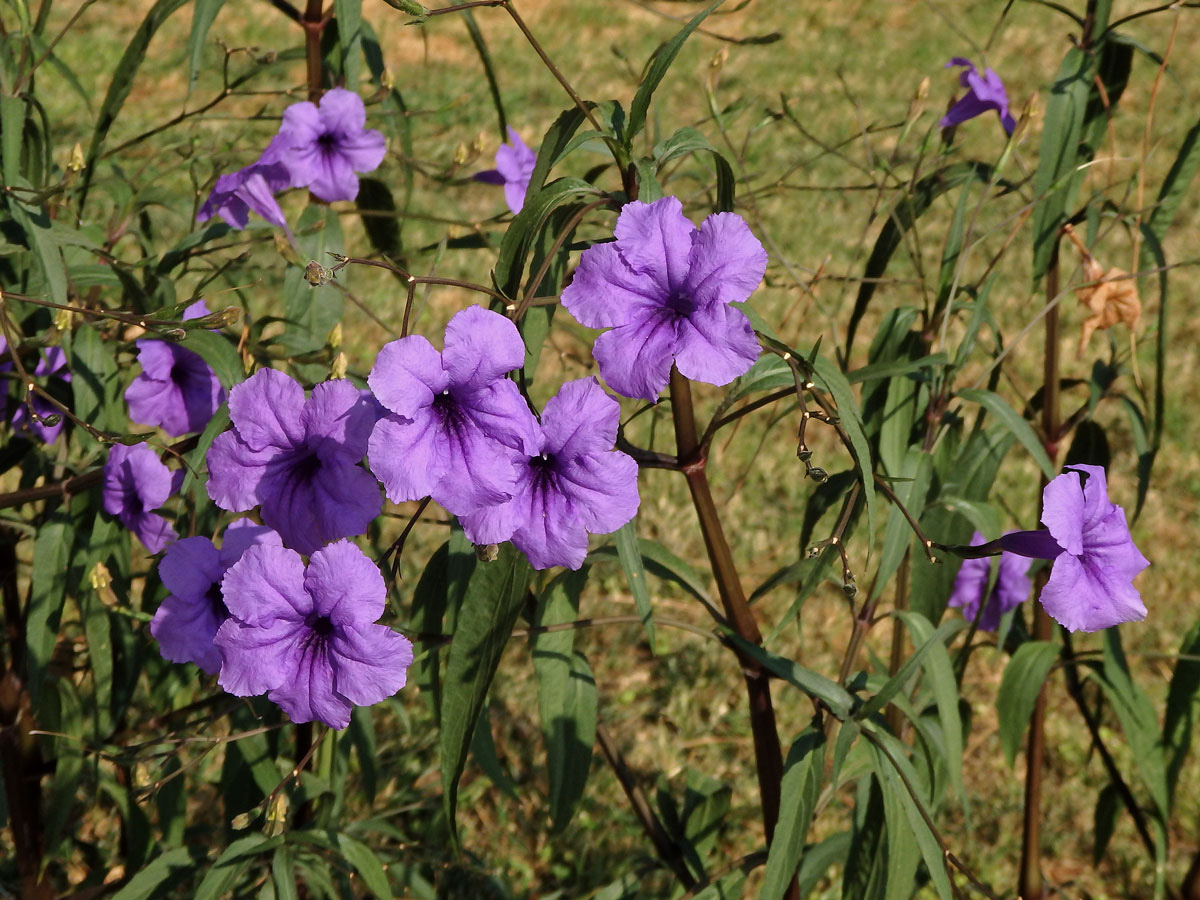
[125,300,226,437]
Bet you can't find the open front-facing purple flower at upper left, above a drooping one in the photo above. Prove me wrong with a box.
[277,88,385,202]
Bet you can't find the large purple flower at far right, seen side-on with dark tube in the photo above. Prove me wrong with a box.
[998,466,1150,631]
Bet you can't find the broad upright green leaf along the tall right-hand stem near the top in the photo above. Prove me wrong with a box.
[1033,47,1092,283]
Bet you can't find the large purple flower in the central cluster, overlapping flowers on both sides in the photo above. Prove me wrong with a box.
[367,306,540,515]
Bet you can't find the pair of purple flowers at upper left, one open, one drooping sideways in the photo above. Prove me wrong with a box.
[196,88,385,229]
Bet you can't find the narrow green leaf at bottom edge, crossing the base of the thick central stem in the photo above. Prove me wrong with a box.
[760,727,826,900]
